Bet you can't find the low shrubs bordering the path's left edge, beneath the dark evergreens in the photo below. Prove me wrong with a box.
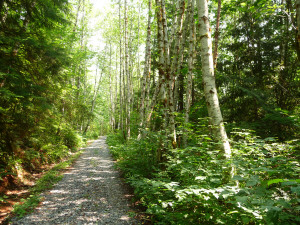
[0,124,84,185]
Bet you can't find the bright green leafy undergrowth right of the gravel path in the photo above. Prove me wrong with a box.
[108,130,300,225]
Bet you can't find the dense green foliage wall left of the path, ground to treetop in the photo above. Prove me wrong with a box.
[0,0,95,183]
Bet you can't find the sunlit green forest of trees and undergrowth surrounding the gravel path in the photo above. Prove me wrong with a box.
[0,0,300,225]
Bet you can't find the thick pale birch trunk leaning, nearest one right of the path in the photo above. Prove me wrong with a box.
[197,0,231,158]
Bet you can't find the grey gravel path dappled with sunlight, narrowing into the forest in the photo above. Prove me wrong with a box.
[13,137,138,225]
